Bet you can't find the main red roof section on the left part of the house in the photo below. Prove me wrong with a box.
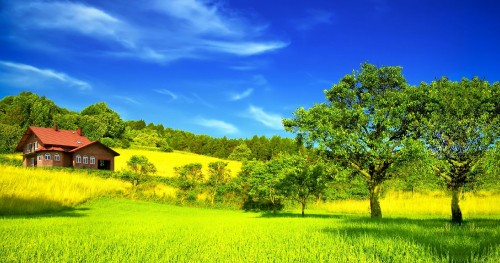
[17,126,91,151]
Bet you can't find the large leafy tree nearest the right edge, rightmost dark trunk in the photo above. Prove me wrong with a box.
[421,78,500,223]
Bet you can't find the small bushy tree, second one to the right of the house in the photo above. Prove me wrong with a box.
[175,163,203,204]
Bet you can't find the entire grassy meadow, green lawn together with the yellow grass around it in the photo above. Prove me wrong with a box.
[0,150,500,262]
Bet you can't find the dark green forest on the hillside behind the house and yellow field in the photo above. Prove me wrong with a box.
[0,92,297,161]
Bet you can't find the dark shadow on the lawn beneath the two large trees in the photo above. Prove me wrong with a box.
[323,217,500,262]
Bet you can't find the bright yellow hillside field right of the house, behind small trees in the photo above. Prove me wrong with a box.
[115,149,241,177]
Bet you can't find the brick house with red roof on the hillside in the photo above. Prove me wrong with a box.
[16,126,120,171]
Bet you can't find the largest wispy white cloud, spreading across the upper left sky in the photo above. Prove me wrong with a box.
[5,0,288,63]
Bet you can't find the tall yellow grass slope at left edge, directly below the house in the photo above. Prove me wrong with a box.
[0,165,130,214]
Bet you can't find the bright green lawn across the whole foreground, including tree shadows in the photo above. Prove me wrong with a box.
[0,198,500,262]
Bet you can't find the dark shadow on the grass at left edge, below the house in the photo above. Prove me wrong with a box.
[0,196,89,218]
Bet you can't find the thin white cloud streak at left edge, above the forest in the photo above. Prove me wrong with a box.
[0,61,92,91]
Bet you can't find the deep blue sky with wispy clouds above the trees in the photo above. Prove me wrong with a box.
[0,0,500,138]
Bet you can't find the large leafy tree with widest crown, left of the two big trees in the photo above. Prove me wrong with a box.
[283,63,421,218]
